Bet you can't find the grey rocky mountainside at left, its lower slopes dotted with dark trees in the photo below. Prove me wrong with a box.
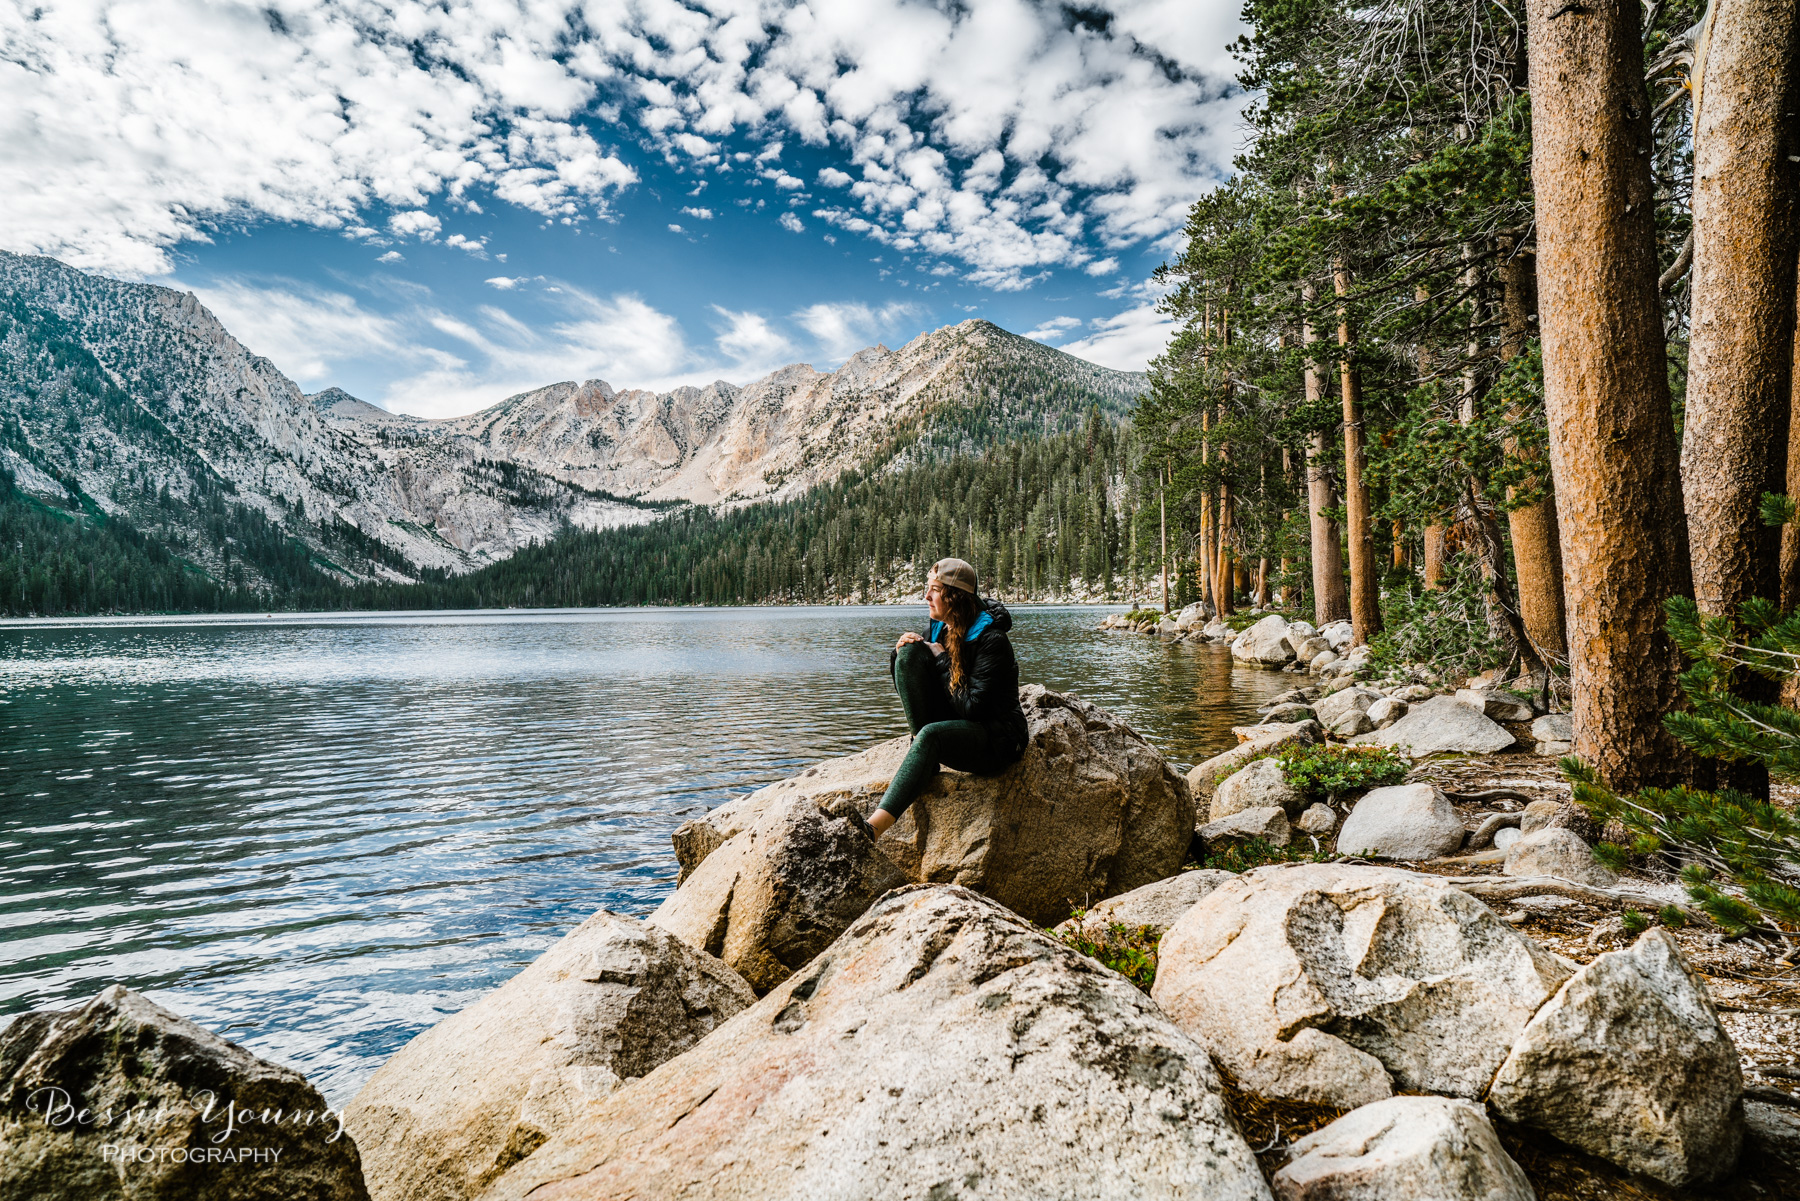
[0,252,653,583]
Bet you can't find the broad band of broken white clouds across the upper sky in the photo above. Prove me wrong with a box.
[0,0,1244,288]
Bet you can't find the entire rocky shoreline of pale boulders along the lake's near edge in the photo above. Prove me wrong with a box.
[0,677,1800,1201]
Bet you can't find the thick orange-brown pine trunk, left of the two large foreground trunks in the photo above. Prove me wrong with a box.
[1526,0,1692,789]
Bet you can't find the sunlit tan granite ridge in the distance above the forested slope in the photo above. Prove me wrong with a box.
[421,321,1143,504]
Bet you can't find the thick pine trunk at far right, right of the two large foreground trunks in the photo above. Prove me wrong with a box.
[1681,0,1800,619]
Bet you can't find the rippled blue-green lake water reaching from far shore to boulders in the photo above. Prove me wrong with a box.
[0,607,1292,1104]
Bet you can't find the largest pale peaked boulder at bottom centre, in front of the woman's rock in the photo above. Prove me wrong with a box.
[488,886,1269,1201]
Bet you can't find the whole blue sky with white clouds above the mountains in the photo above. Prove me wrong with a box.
[0,0,1246,416]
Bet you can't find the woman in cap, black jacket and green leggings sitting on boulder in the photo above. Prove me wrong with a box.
[869,558,1028,834]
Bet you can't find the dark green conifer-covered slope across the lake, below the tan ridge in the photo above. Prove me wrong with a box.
[340,421,1156,609]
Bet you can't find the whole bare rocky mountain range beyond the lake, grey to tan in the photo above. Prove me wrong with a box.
[0,252,1145,587]
